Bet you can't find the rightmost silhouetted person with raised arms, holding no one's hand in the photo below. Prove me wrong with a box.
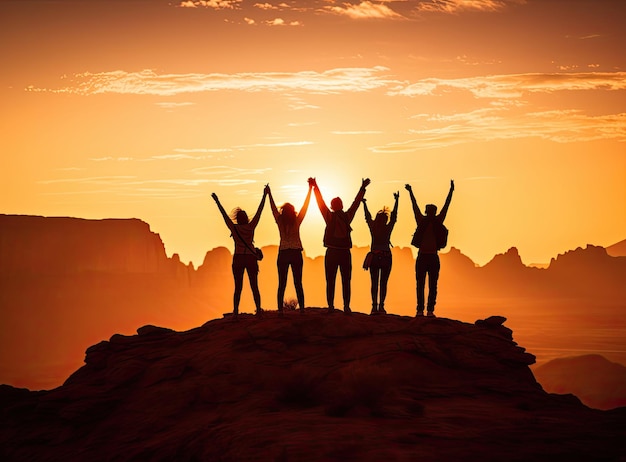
[405,180,454,316]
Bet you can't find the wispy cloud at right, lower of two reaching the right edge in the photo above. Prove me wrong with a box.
[370,109,626,153]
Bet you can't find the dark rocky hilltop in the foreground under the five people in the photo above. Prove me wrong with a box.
[0,309,626,461]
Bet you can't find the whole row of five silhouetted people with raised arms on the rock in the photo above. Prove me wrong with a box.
[211,178,454,319]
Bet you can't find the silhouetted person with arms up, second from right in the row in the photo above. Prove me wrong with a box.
[363,192,400,314]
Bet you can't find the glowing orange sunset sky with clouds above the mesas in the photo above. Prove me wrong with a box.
[0,0,626,266]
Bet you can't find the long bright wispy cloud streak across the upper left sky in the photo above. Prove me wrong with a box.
[26,66,399,96]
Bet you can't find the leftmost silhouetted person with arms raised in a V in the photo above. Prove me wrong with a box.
[211,187,268,318]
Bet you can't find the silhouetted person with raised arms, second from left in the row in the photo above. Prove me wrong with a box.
[267,181,313,314]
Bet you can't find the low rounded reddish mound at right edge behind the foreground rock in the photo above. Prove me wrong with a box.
[534,354,626,409]
